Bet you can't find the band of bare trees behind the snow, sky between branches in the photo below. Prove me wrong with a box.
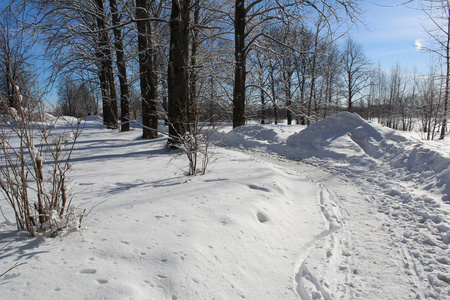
[0,0,449,139]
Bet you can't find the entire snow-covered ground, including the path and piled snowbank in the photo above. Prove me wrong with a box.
[0,113,450,300]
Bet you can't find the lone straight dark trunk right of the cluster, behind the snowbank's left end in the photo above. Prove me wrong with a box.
[233,0,246,128]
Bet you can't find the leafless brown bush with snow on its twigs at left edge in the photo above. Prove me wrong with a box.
[0,84,81,236]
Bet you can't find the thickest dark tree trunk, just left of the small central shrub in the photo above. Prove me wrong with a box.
[168,0,190,148]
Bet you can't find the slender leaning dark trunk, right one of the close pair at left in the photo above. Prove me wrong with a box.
[109,0,130,131]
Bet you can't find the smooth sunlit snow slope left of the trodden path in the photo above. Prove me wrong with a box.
[0,118,335,299]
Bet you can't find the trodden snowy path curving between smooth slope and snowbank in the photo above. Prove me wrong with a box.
[251,152,448,300]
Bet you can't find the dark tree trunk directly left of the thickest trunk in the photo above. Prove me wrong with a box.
[136,0,158,139]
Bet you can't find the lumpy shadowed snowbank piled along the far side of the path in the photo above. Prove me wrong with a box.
[222,112,450,202]
